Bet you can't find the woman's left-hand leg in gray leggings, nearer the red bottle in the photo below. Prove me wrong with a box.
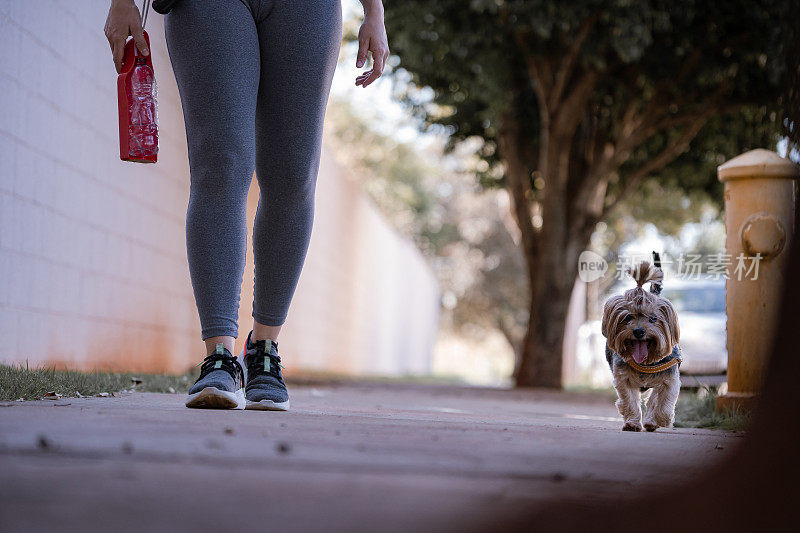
[162,0,260,353]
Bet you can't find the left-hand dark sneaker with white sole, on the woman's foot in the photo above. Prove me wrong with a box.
[186,344,245,409]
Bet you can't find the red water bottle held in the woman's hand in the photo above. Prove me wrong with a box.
[117,32,158,163]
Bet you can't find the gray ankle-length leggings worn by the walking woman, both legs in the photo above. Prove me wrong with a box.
[166,0,342,339]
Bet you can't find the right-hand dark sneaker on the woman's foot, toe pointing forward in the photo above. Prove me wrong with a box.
[242,331,289,411]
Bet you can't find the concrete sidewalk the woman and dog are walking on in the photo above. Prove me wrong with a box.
[0,383,741,533]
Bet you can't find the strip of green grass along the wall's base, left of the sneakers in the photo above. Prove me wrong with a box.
[0,365,198,400]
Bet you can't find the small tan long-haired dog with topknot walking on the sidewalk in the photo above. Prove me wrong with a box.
[603,259,681,431]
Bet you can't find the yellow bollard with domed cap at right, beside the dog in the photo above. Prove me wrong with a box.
[717,149,800,410]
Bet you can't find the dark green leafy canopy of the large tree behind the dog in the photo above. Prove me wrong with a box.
[386,0,790,202]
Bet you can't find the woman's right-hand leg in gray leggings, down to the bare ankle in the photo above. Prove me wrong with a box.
[252,0,342,340]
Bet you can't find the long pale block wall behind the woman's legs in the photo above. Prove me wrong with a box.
[0,0,438,373]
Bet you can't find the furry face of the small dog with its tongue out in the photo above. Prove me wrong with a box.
[603,287,680,364]
